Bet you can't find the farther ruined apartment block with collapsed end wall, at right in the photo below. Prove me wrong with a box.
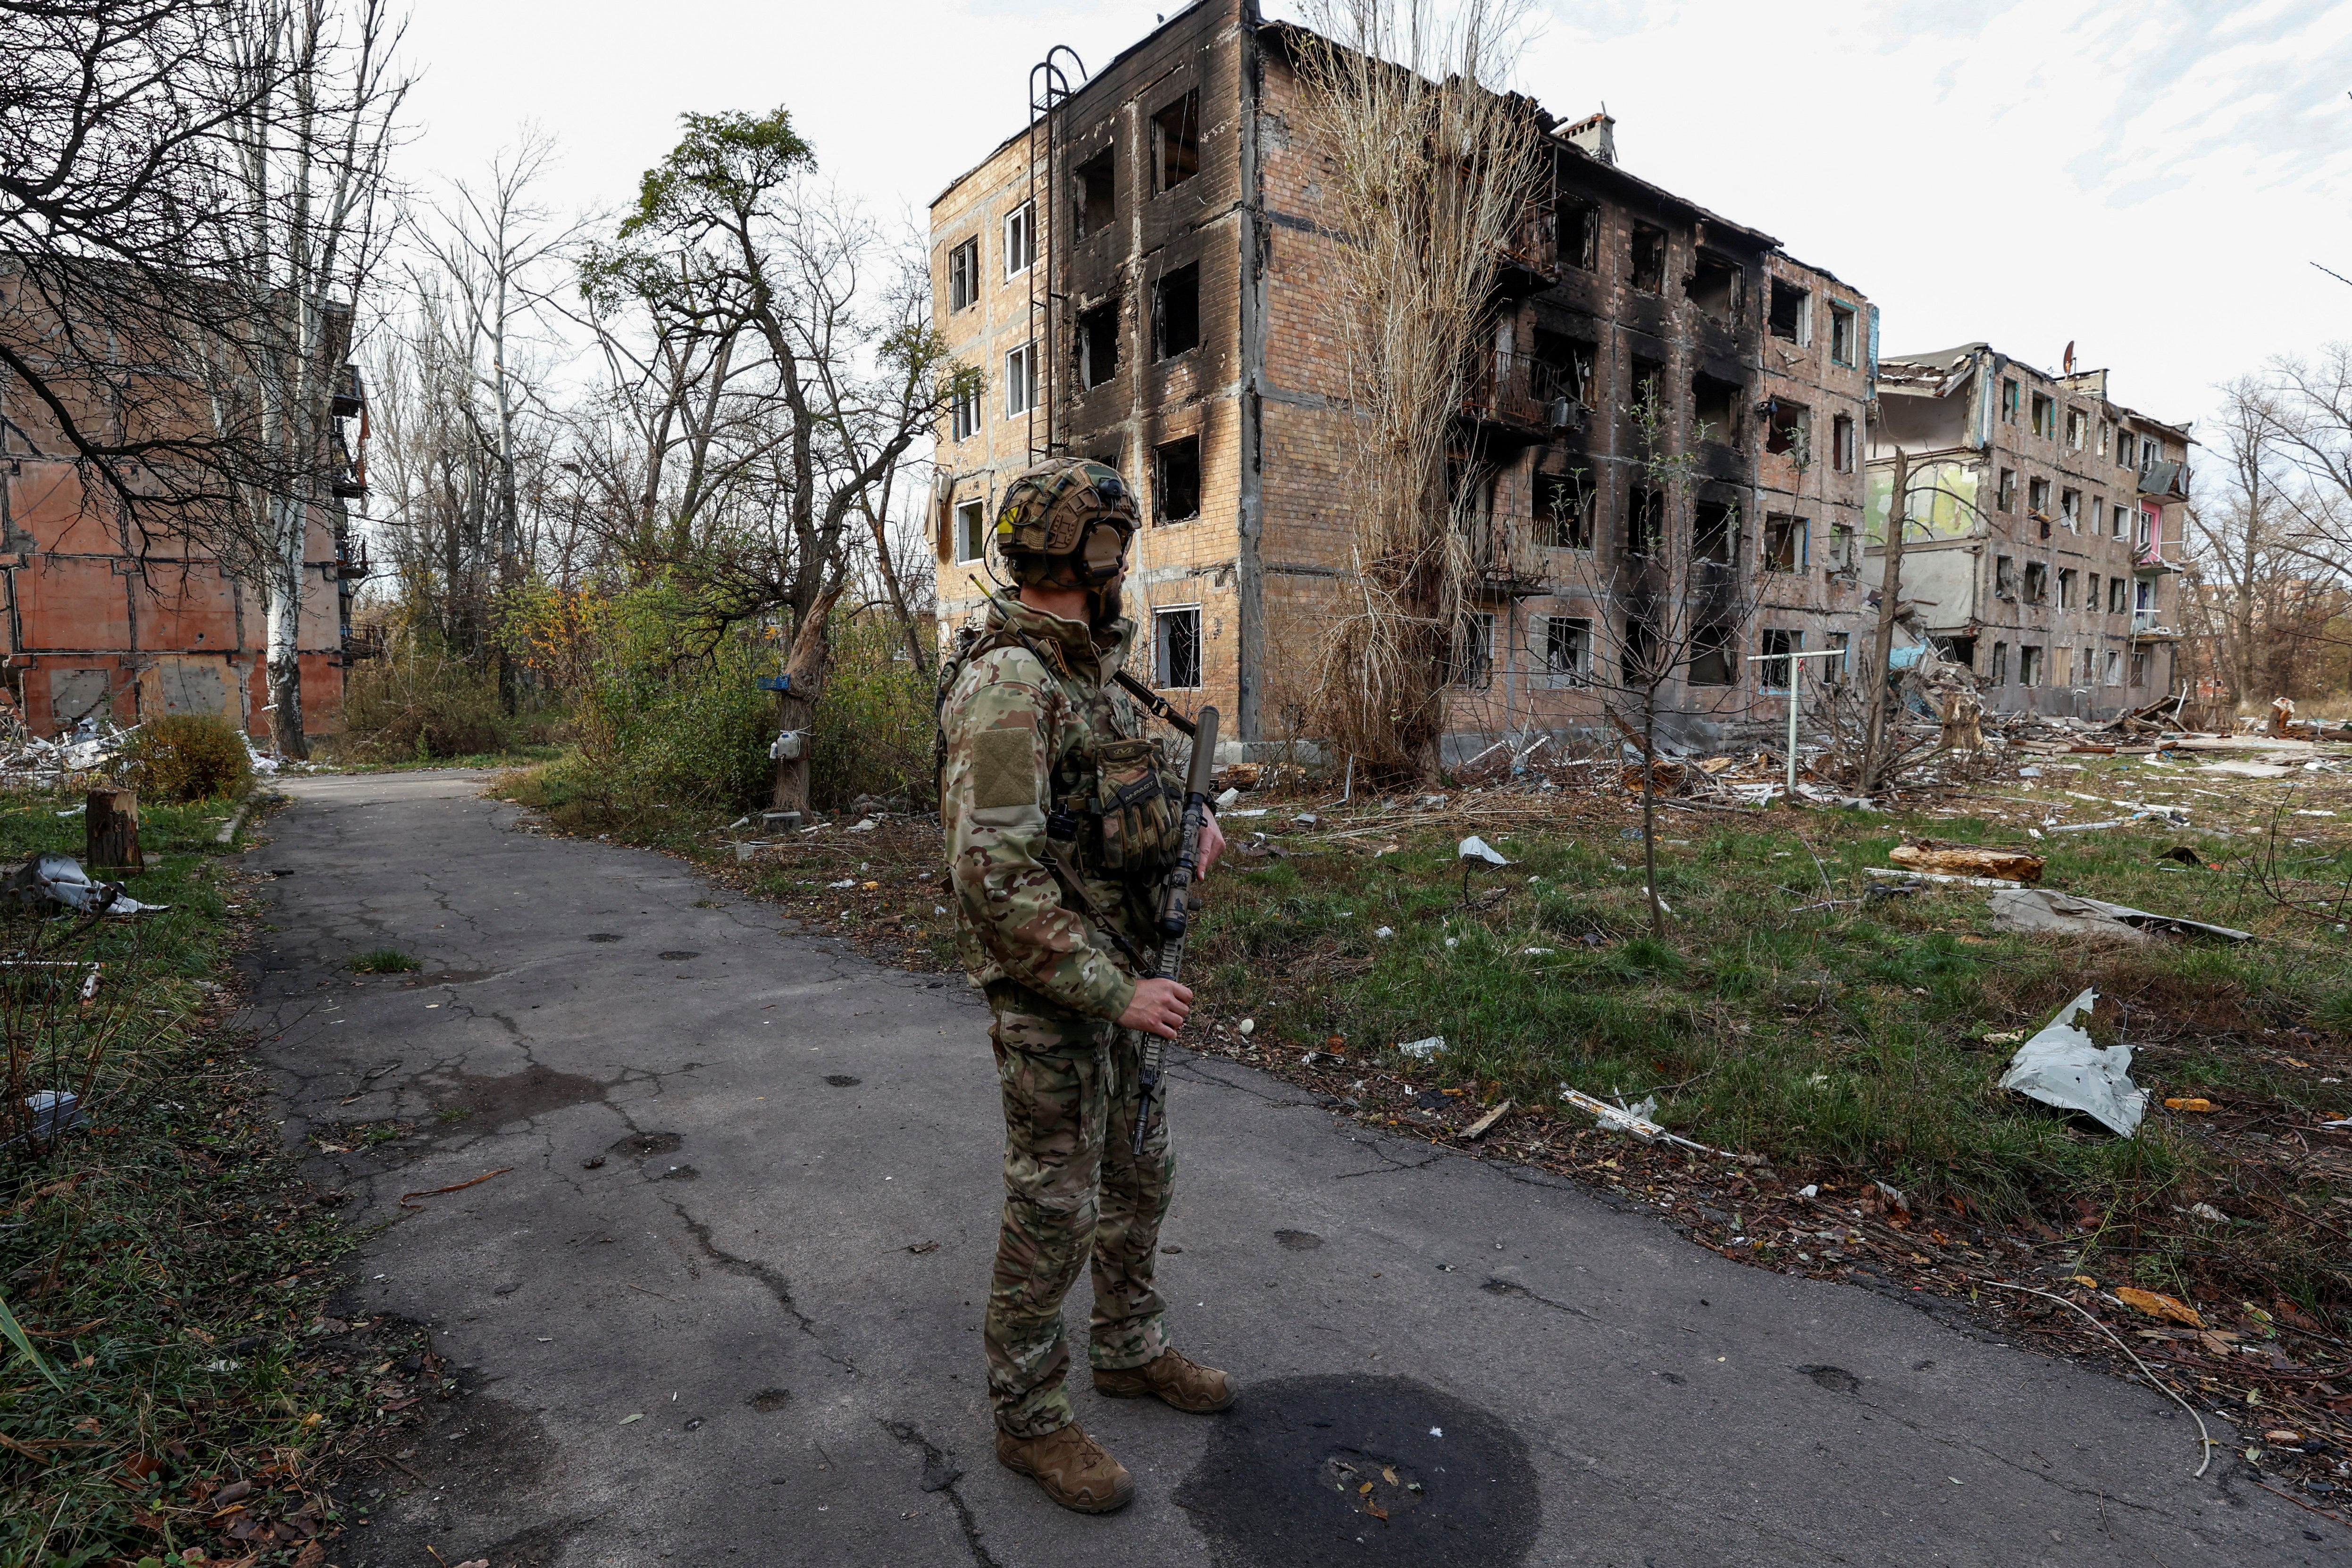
[1870,343,2190,719]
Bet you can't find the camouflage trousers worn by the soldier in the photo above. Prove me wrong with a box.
[983,1001,1176,1436]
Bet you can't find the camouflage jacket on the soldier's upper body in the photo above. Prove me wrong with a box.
[938,592,1164,1018]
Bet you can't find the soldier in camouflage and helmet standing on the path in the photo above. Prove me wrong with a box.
[938,458,1235,1514]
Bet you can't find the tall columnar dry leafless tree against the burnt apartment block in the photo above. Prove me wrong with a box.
[1301,0,1548,773]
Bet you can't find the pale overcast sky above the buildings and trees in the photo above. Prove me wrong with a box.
[404,0,2352,435]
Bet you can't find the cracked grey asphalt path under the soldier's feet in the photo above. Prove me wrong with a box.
[244,773,2352,1568]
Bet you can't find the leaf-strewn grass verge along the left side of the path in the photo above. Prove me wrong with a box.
[0,797,390,1566]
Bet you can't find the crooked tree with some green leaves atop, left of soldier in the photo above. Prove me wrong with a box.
[583,108,976,809]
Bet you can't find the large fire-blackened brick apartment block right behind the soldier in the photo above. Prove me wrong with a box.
[931,0,2178,755]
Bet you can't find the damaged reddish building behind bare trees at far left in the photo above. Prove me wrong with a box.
[0,275,367,736]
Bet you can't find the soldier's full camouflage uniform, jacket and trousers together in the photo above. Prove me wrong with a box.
[941,595,1180,1436]
